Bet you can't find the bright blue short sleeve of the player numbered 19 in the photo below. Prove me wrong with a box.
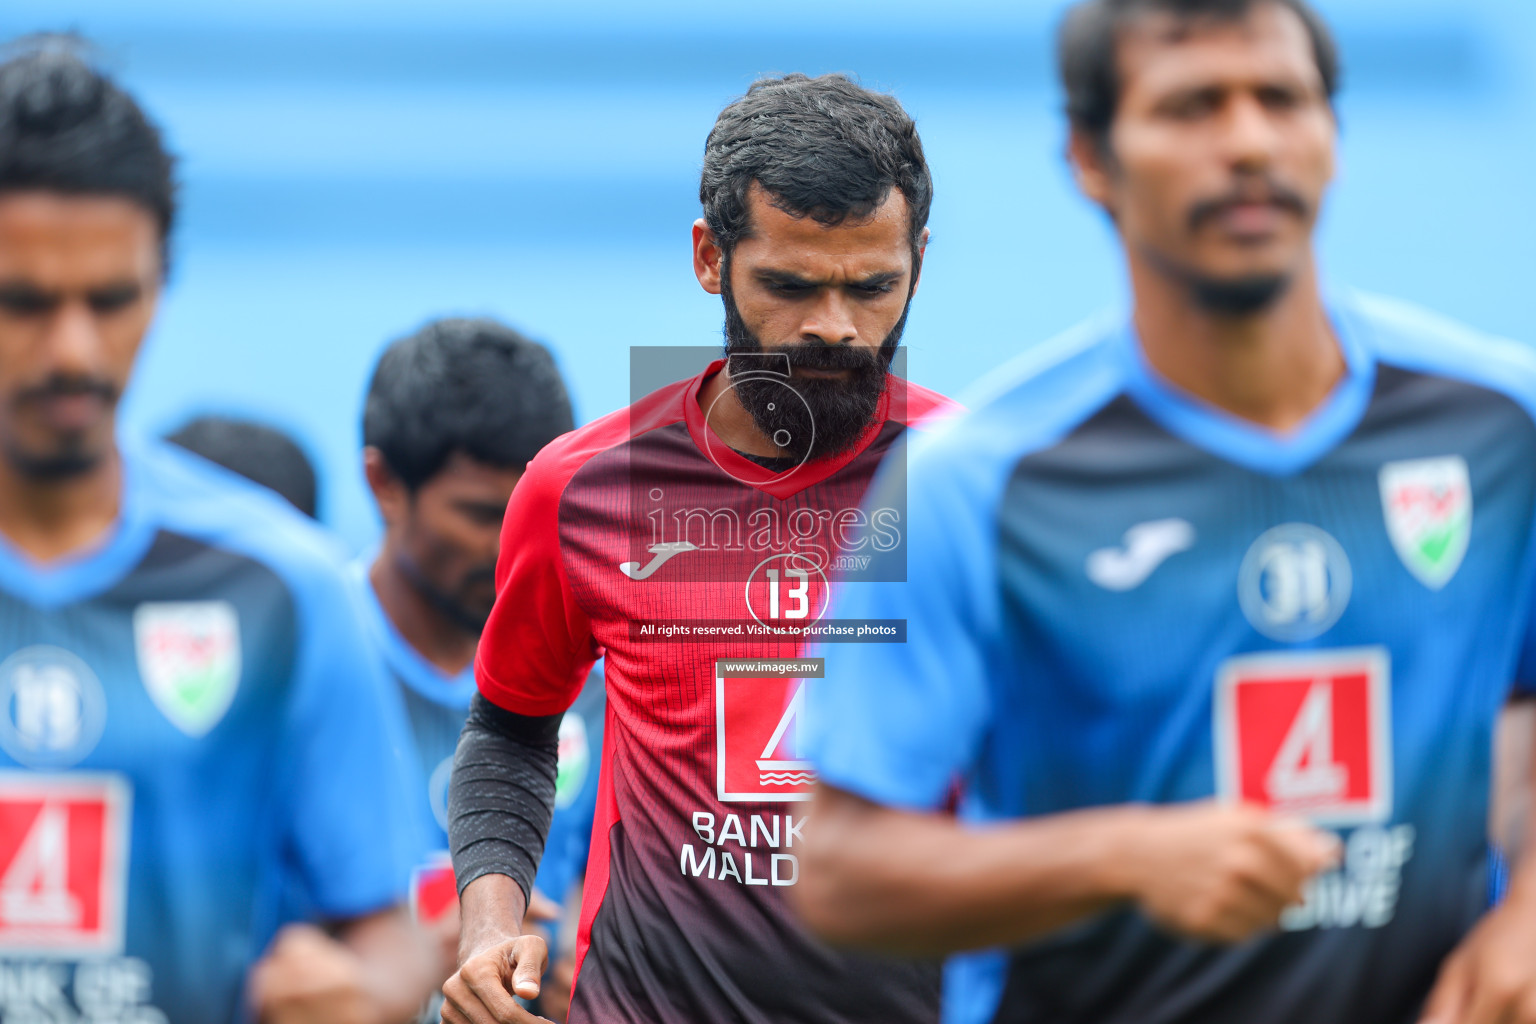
[284,567,429,920]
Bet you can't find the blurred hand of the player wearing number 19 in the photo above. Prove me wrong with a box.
[250,924,386,1024]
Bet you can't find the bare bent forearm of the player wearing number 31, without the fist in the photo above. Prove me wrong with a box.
[797,792,1140,953]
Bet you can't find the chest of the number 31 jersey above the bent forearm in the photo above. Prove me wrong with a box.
[992,370,1536,824]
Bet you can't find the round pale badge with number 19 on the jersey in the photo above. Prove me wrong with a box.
[0,643,106,768]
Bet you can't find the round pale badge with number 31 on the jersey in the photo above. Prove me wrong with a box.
[1238,522,1352,642]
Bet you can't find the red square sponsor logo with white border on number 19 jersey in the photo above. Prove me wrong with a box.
[0,772,129,956]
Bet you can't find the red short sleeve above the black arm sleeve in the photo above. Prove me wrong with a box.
[475,445,598,715]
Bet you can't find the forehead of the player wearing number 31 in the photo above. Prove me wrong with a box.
[1115,3,1322,106]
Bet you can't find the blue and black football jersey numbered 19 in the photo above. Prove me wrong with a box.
[0,444,422,1024]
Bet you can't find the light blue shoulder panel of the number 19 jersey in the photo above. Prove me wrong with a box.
[124,441,347,596]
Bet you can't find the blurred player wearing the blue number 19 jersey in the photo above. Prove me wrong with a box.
[0,41,430,1024]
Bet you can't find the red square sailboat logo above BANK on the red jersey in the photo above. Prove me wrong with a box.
[714,668,816,801]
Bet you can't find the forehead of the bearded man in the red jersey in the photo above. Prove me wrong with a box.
[733,184,911,273]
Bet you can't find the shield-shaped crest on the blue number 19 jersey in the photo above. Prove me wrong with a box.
[134,600,240,738]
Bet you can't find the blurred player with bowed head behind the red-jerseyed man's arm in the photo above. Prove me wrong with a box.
[353,319,602,1019]
